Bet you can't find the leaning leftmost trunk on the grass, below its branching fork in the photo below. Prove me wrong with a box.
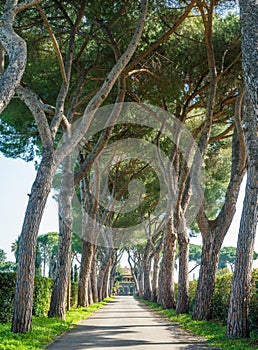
[11,152,55,333]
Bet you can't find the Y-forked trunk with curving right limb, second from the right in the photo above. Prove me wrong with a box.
[193,112,246,320]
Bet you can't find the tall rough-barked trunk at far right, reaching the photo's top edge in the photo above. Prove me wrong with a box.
[227,0,258,337]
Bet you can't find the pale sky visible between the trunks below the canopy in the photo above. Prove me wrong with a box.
[0,153,258,266]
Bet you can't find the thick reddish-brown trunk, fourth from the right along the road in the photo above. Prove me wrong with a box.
[158,217,176,309]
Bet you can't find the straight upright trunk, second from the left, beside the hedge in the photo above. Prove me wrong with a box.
[48,156,74,320]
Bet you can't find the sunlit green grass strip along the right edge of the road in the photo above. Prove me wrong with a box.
[140,299,258,350]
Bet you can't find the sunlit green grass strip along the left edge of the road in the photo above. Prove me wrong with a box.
[0,298,113,350]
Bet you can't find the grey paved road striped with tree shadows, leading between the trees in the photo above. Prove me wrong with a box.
[47,296,209,350]
